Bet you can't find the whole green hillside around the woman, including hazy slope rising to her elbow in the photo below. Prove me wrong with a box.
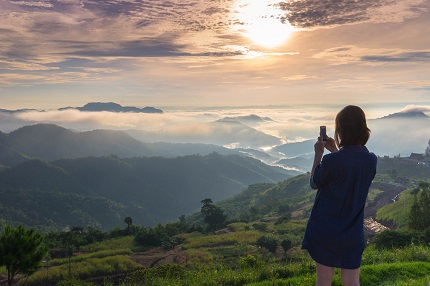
[0,171,430,286]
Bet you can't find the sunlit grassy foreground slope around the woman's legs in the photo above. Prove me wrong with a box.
[10,221,430,286]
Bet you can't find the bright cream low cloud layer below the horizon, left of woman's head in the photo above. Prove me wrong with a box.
[0,107,335,141]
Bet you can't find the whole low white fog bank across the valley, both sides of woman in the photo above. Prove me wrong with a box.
[0,105,430,156]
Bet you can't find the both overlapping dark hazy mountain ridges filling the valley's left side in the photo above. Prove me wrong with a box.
[0,124,291,229]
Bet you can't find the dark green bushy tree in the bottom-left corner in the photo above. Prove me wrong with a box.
[0,226,48,285]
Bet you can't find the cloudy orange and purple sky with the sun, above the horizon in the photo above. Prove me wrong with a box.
[0,0,430,109]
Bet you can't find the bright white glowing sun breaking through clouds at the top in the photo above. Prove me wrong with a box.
[235,0,293,48]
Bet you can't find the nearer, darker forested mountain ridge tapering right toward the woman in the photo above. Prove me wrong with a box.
[0,153,289,229]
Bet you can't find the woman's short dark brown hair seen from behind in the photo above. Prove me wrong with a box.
[334,105,370,147]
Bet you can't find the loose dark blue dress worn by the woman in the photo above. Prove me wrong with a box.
[302,146,377,269]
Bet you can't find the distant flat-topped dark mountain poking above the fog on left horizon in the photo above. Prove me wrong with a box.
[58,102,163,113]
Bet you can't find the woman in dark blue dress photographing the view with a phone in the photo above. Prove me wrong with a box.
[302,105,376,286]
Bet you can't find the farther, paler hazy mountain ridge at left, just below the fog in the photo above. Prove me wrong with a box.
[0,124,237,166]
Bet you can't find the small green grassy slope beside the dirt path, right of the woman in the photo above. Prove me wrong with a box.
[376,190,414,230]
